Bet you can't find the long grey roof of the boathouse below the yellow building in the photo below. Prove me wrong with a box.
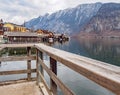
[4,32,38,37]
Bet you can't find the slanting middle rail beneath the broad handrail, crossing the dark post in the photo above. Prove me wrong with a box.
[38,58,74,95]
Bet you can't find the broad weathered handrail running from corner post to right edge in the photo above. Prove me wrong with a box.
[35,44,120,94]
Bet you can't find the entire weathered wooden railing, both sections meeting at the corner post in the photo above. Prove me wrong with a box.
[0,44,120,95]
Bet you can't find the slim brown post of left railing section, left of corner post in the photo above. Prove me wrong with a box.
[27,47,31,80]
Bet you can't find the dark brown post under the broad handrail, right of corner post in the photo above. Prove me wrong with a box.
[50,57,57,95]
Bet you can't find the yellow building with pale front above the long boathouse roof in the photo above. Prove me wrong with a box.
[4,23,26,32]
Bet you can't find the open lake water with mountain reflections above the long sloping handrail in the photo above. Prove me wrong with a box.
[54,38,120,66]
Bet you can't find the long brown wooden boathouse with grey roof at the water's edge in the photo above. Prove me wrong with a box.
[4,32,40,43]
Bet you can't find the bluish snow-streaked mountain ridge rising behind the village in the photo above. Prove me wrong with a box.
[25,3,102,34]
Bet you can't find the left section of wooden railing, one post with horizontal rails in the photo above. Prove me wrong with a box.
[0,44,36,84]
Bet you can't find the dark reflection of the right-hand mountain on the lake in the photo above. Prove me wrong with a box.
[79,39,120,66]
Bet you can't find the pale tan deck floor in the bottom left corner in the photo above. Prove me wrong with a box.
[0,82,43,95]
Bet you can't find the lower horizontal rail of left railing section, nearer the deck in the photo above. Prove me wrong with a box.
[0,69,36,75]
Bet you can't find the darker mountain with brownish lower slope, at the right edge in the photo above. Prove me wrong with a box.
[80,3,120,37]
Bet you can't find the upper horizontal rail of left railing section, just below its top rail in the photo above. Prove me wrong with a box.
[0,56,36,62]
